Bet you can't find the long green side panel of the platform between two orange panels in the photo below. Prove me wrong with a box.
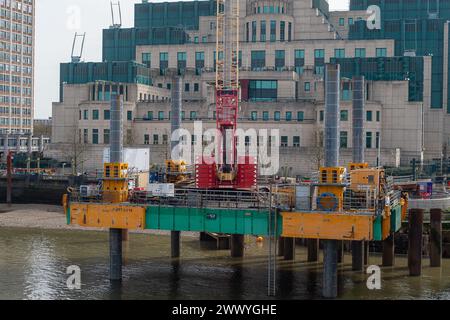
[145,206,282,236]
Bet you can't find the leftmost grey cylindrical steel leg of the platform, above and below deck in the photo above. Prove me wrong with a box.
[109,95,123,281]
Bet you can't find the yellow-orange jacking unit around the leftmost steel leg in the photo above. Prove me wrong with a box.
[103,163,128,203]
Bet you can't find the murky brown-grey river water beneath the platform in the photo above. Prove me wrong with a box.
[0,228,450,300]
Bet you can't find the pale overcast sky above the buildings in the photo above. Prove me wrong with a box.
[35,0,348,119]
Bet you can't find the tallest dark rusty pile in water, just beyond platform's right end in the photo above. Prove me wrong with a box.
[408,209,423,276]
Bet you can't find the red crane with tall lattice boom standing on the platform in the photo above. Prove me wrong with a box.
[195,0,257,189]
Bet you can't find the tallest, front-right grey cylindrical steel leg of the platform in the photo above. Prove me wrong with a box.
[322,64,341,298]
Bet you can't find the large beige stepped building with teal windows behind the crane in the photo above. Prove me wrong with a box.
[49,0,442,176]
